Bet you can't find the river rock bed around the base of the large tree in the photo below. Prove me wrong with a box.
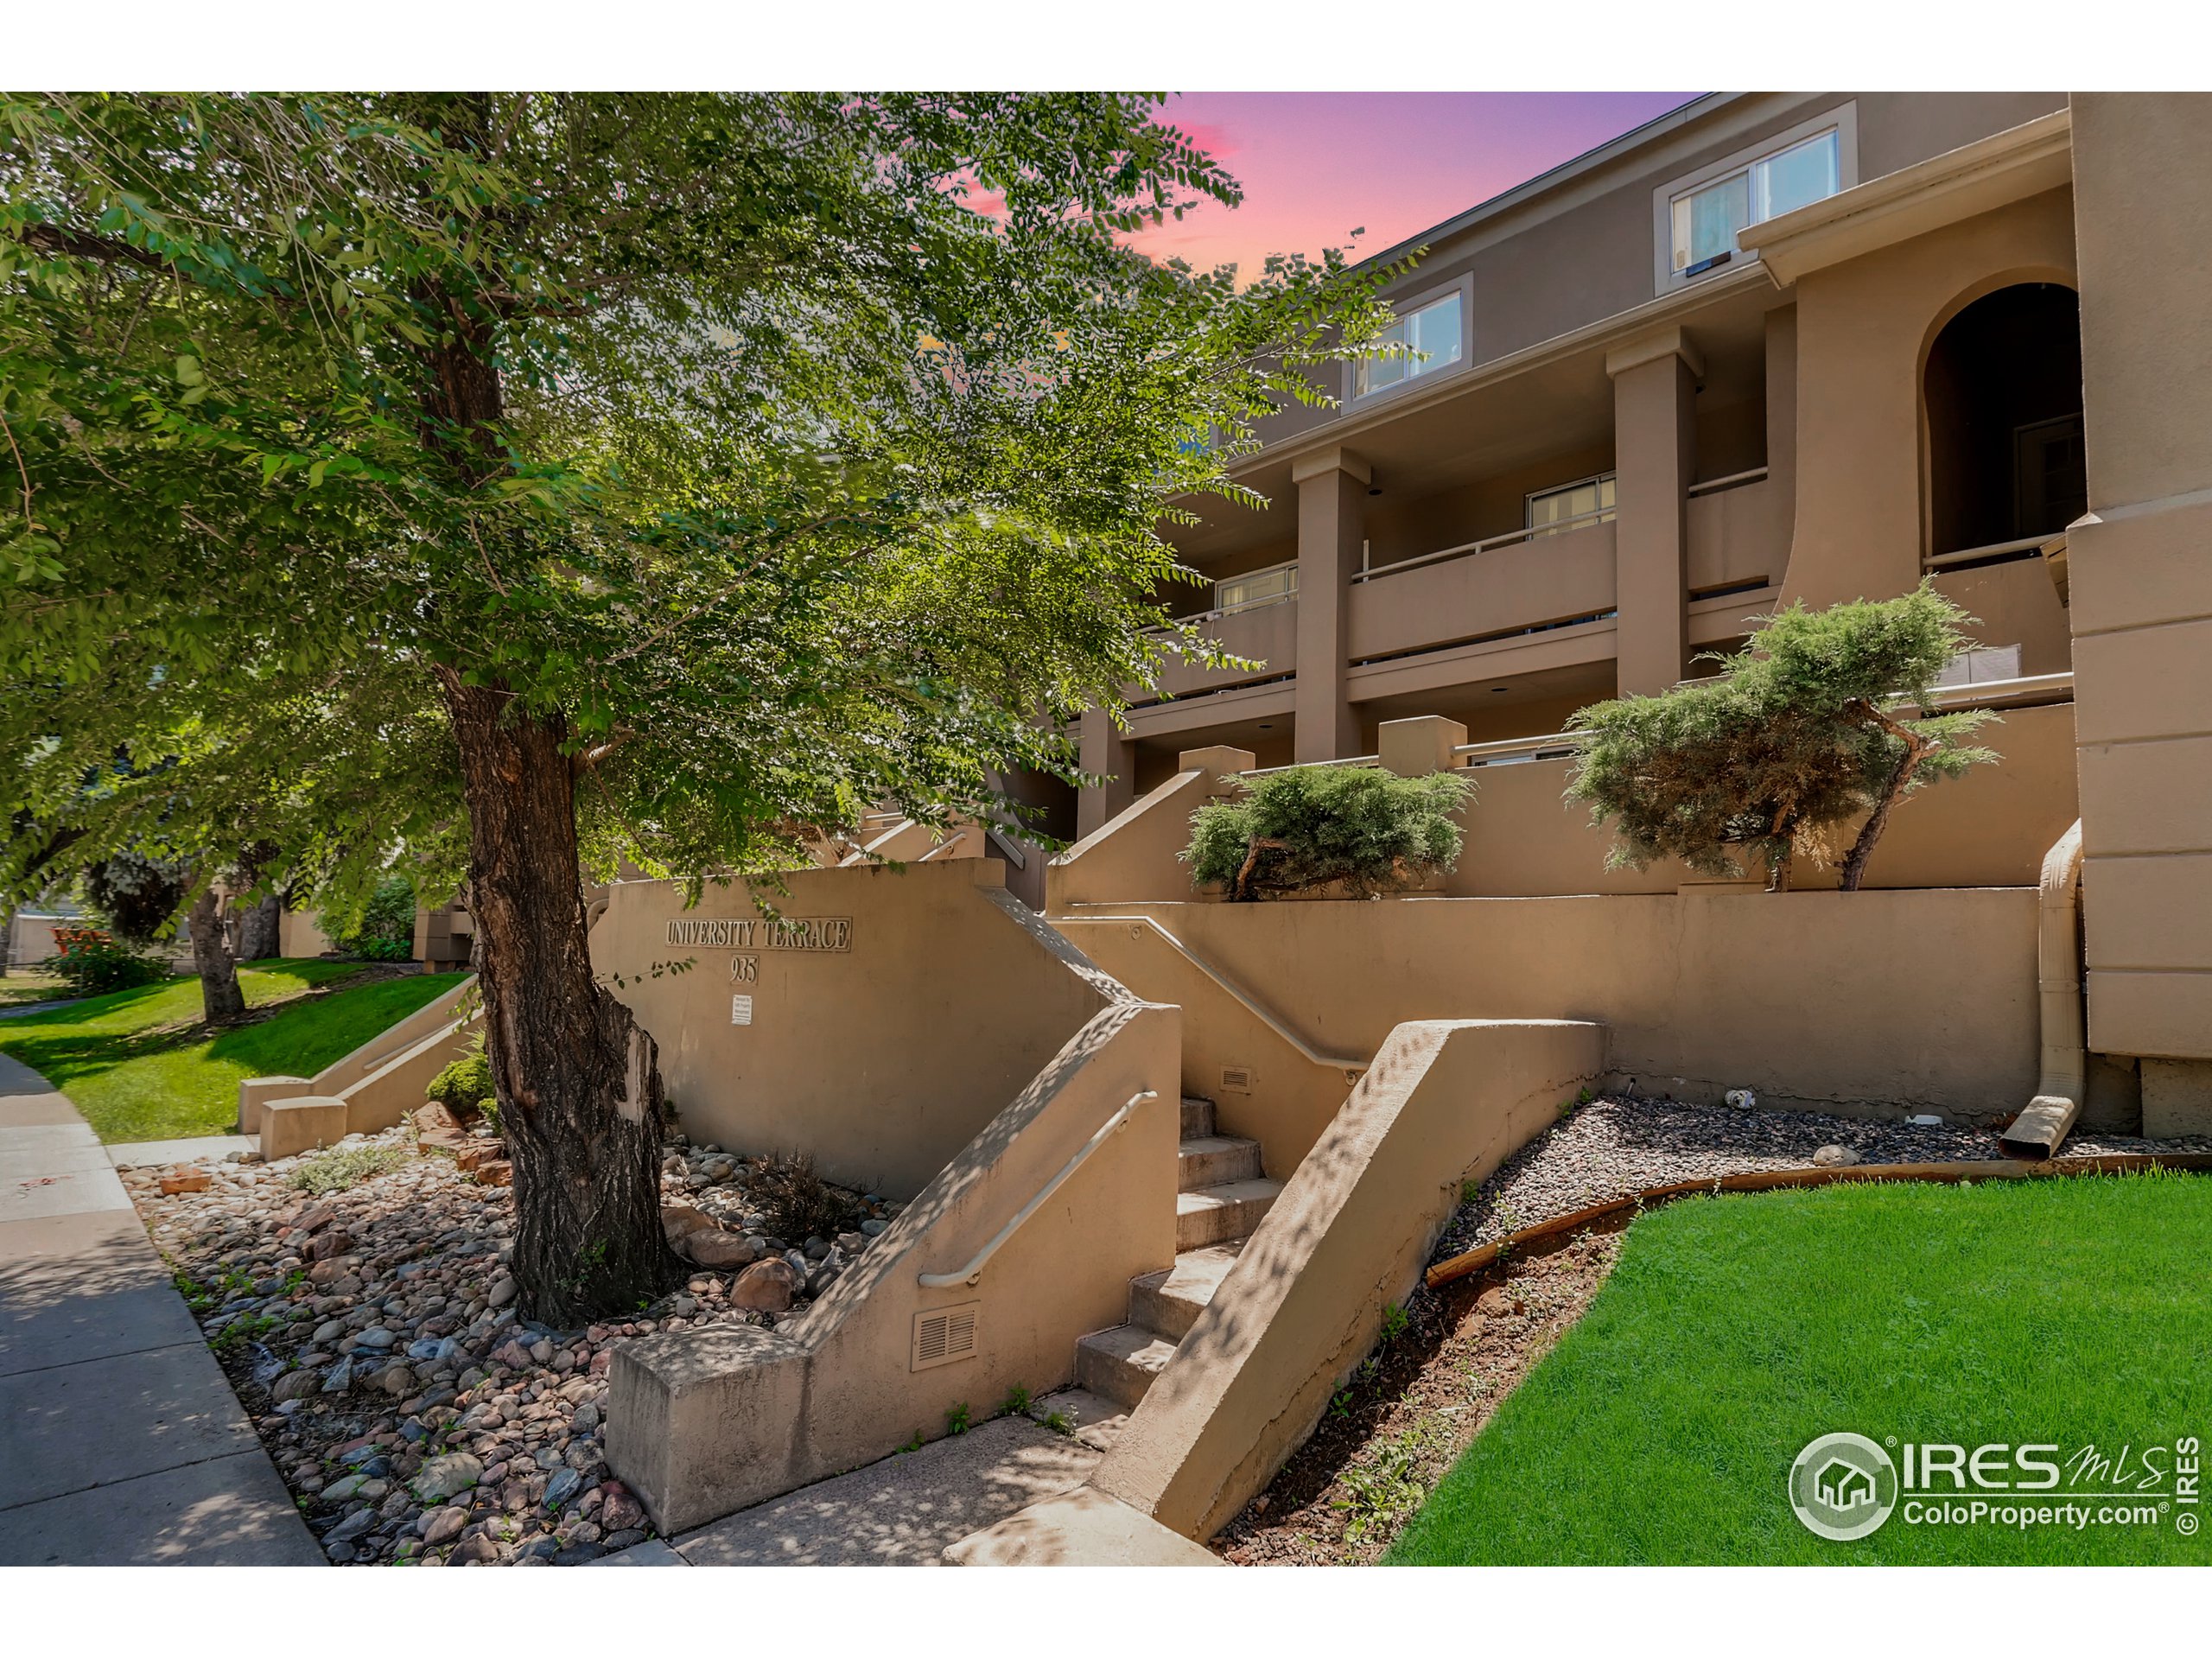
[124,1109,900,1566]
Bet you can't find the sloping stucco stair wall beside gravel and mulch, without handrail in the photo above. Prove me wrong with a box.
[1090,1020,1606,1537]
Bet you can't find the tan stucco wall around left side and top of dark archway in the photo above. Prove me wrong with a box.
[1783,190,2075,608]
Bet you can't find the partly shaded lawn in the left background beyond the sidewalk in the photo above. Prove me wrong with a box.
[0,957,465,1141]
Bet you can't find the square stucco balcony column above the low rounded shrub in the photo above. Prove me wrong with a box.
[1289,449,1374,766]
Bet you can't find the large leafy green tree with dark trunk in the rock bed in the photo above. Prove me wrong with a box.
[0,93,1395,1323]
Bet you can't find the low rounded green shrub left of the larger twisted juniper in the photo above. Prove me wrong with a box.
[1181,766,1476,900]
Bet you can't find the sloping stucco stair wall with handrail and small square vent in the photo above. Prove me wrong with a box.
[606,995,1181,1533]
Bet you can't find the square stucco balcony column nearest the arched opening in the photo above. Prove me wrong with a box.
[1606,327,1706,696]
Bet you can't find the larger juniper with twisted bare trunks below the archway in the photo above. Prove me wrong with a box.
[1566,582,1998,892]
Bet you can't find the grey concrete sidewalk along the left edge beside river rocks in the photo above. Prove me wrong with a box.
[0,1055,323,1566]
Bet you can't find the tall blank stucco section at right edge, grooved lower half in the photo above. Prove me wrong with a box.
[2066,93,2212,1106]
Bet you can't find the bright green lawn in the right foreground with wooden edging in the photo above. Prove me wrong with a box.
[1389,1174,2212,1564]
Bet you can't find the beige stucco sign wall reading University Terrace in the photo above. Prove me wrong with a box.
[591,858,1113,1197]
